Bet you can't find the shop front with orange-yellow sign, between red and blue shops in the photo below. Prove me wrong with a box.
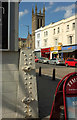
[50,46,61,59]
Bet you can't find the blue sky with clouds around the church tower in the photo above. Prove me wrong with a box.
[19,0,75,38]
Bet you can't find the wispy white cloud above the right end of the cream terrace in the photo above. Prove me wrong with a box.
[54,4,75,18]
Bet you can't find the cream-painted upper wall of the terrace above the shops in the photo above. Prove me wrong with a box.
[35,15,77,49]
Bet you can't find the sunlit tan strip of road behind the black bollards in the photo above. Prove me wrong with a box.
[36,63,77,79]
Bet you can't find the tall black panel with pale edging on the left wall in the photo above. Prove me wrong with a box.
[0,2,10,49]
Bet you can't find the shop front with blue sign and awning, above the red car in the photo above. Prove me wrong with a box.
[59,45,77,60]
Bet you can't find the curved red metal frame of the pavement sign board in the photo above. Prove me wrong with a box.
[50,72,76,120]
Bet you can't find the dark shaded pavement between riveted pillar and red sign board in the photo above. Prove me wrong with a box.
[36,74,60,118]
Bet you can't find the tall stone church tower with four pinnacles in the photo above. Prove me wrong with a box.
[32,5,45,49]
